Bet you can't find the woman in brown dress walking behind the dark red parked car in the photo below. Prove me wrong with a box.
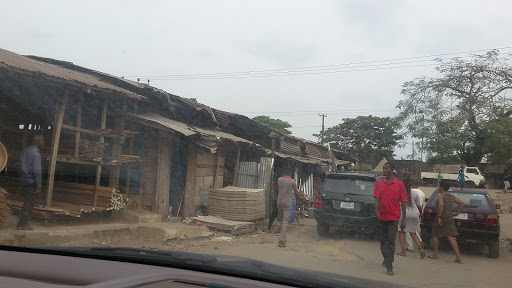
[428,181,464,264]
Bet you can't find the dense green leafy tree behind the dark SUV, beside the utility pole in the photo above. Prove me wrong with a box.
[314,115,403,163]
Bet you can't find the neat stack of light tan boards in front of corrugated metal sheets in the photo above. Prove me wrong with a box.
[208,186,265,221]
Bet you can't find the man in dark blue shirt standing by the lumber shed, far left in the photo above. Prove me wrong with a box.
[17,134,44,230]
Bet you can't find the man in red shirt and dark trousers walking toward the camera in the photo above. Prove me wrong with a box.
[373,163,407,276]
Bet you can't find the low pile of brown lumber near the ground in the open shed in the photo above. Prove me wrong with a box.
[53,182,119,208]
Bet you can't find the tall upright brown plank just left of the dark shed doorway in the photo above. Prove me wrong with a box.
[156,135,172,218]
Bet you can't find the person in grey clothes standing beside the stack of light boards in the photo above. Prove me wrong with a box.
[277,175,302,247]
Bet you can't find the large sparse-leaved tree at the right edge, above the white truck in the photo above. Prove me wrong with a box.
[397,50,512,166]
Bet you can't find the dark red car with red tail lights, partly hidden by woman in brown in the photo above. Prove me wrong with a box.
[420,188,500,258]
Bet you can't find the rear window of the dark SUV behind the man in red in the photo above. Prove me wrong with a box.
[322,178,375,195]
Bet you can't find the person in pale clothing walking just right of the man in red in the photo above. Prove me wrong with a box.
[398,178,425,259]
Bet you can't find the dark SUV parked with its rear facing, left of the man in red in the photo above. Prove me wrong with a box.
[314,173,382,238]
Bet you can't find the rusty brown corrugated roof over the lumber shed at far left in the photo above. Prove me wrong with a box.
[0,49,146,100]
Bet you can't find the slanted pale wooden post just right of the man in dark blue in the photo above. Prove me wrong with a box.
[46,91,69,207]
